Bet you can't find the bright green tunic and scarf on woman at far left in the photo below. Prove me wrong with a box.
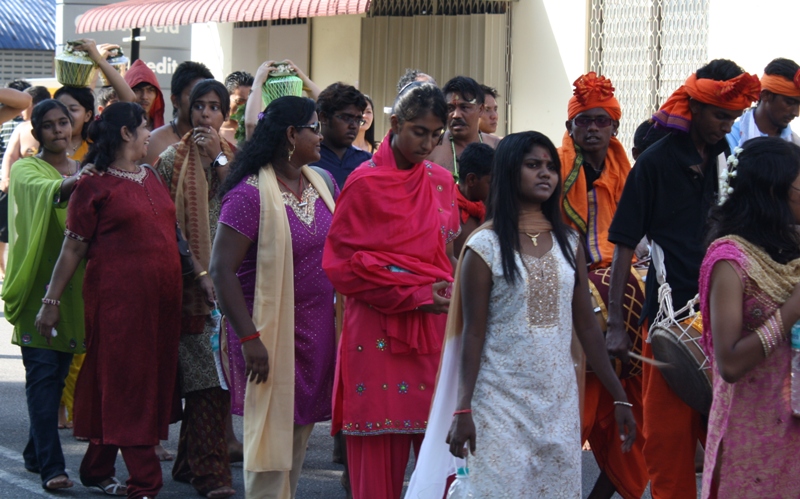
[2,157,85,353]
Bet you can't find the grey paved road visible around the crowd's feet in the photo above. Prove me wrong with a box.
[0,303,688,499]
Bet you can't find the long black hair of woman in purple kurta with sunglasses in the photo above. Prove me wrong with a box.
[219,96,317,198]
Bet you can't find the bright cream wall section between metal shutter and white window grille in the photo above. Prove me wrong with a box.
[510,0,587,142]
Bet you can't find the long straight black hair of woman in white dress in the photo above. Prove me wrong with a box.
[489,132,576,284]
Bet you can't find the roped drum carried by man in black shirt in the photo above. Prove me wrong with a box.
[650,313,713,416]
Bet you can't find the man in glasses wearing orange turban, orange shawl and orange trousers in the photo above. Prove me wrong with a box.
[558,72,648,499]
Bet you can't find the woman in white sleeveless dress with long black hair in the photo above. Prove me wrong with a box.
[406,132,636,499]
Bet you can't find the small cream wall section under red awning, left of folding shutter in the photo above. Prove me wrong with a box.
[308,15,364,88]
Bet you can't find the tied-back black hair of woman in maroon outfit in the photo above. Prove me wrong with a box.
[82,102,146,172]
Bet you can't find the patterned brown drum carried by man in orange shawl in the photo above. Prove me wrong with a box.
[586,267,647,379]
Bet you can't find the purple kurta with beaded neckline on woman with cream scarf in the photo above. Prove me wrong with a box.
[219,175,339,425]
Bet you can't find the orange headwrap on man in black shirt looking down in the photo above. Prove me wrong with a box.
[653,73,761,132]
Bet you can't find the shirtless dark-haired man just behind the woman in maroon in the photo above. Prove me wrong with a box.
[142,61,214,165]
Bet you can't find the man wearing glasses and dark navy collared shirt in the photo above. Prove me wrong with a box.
[314,83,372,189]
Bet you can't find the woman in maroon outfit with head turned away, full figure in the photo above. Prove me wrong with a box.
[37,103,181,498]
